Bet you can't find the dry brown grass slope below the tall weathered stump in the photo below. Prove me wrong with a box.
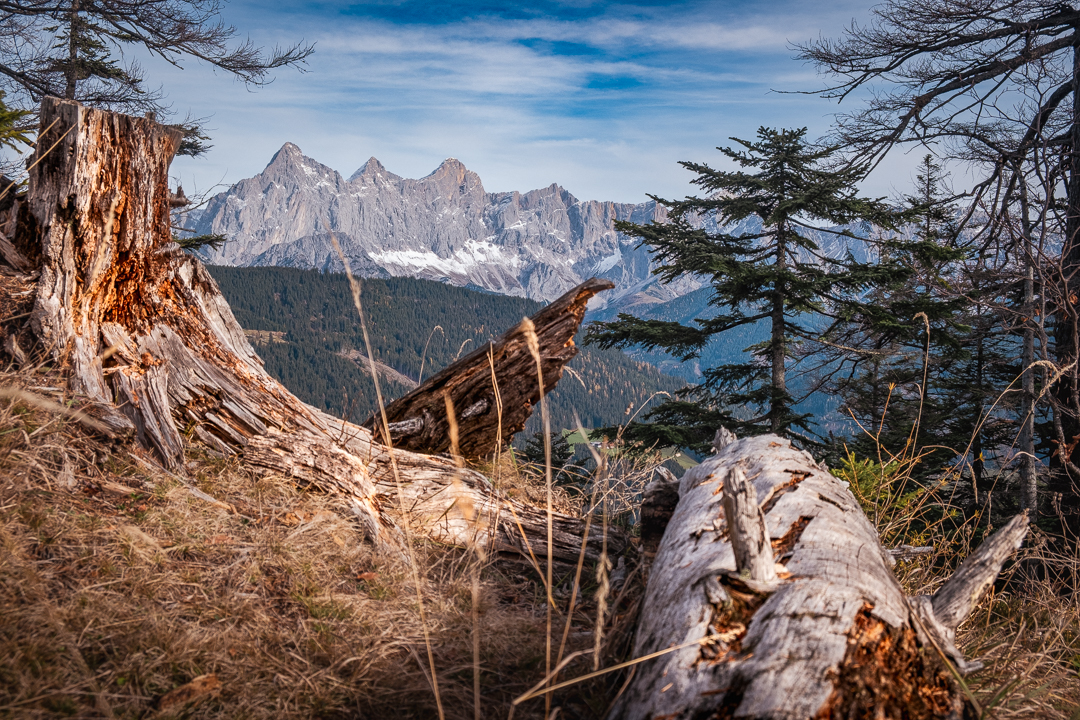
[0,371,625,718]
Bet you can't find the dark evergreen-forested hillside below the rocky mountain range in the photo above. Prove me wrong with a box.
[210,267,686,434]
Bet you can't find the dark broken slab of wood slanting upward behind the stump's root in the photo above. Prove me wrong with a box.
[364,277,615,458]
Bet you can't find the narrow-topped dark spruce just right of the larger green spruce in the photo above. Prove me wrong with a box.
[829,154,971,460]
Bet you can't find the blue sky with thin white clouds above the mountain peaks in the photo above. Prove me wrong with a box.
[156,0,914,202]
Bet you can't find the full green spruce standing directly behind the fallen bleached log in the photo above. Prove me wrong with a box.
[588,127,894,450]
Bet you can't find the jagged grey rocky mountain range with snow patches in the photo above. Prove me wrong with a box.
[187,142,872,310]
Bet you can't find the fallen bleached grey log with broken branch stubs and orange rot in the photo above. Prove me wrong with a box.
[609,435,1027,720]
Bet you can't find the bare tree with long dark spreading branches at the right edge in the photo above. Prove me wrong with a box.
[798,0,1080,518]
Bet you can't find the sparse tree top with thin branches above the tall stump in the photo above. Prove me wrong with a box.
[0,0,313,154]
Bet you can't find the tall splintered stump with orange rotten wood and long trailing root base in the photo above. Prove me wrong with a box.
[0,98,624,562]
